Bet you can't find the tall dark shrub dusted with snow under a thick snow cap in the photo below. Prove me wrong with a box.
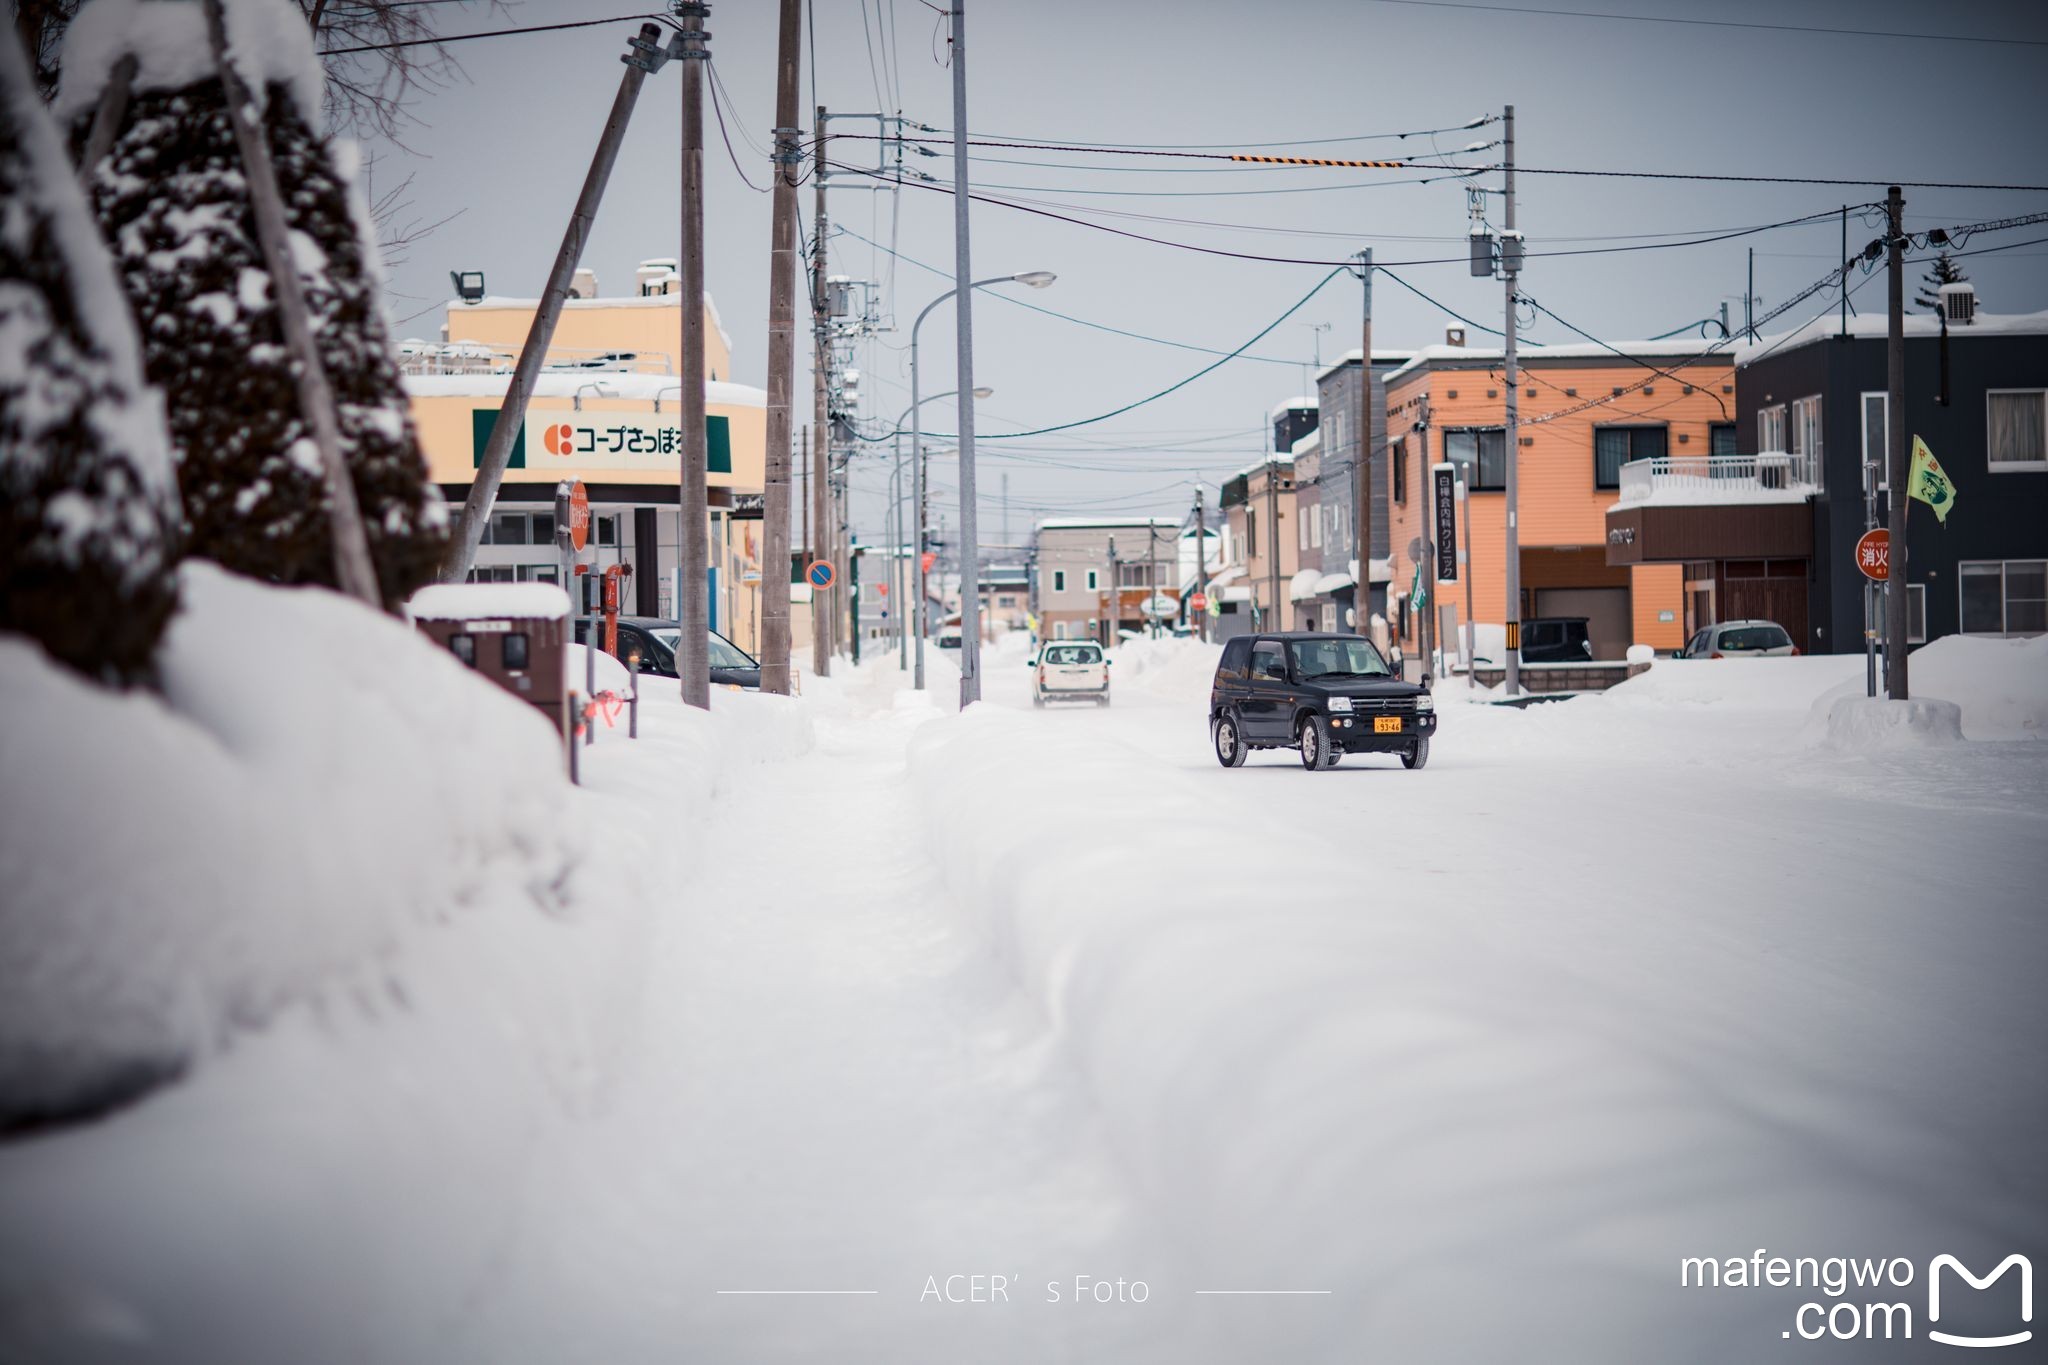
[57,0,446,606]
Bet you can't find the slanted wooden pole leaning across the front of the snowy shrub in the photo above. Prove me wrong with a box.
[205,0,383,608]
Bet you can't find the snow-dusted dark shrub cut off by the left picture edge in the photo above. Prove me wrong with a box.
[0,21,178,681]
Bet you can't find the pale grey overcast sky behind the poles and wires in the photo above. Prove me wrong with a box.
[373,0,2048,542]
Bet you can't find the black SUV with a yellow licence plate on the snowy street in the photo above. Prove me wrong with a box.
[1208,632,1436,772]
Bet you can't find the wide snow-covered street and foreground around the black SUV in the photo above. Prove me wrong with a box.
[0,643,2048,1361]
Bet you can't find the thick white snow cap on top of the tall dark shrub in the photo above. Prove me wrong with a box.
[51,0,324,129]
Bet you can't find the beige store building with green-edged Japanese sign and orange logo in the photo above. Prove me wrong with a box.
[399,262,778,651]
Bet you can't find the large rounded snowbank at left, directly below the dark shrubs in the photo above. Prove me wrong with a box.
[0,563,584,1124]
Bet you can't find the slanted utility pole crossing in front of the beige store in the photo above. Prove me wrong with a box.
[440,25,667,587]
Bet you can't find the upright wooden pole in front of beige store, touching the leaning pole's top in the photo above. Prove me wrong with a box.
[672,0,711,710]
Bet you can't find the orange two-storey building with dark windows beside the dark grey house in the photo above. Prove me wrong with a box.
[1374,340,1735,661]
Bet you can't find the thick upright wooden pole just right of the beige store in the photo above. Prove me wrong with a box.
[762,0,803,696]
